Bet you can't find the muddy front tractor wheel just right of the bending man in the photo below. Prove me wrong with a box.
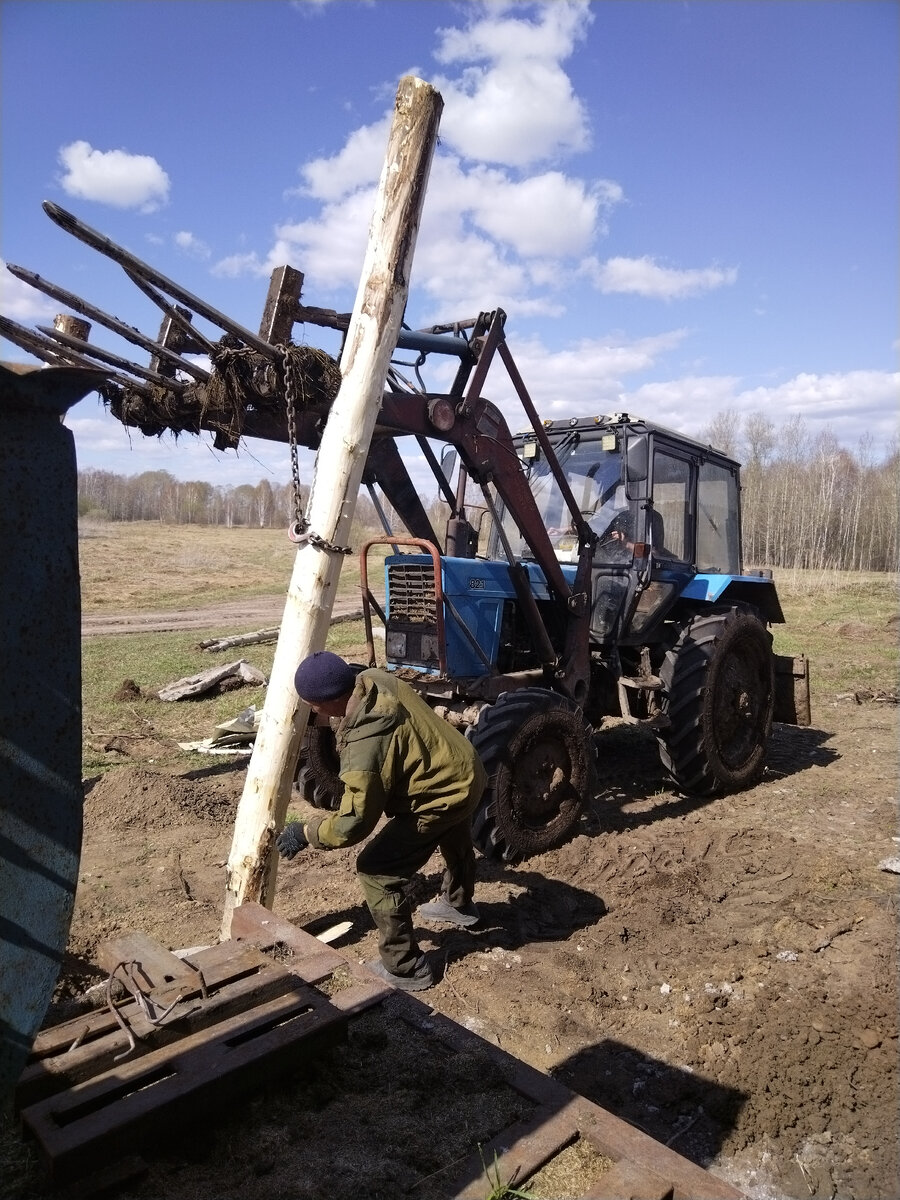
[468,688,596,863]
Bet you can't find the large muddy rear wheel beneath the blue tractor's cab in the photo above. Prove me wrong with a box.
[659,607,775,796]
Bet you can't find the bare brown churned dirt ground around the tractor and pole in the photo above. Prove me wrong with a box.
[7,609,900,1200]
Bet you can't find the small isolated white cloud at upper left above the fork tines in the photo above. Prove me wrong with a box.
[59,142,169,212]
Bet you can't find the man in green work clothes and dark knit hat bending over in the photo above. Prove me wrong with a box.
[276,650,486,991]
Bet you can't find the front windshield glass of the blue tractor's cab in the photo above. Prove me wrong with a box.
[494,431,634,562]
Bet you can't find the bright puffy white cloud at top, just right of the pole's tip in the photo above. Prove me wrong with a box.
[433,0,593,167]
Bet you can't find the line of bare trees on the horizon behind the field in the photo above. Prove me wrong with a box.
[78,412,900,571]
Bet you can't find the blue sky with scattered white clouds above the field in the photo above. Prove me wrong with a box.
[0,0,900,485]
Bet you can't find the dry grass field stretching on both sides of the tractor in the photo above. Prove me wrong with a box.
[79,522,900,774]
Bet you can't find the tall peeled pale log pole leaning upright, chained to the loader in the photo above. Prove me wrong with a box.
[222,76,444,940]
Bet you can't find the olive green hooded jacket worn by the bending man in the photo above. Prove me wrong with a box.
[305,667,486,850]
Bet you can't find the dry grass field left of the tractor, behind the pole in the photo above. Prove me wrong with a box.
[78,521,376,775]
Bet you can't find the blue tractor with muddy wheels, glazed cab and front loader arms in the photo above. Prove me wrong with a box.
[299,312,810,862]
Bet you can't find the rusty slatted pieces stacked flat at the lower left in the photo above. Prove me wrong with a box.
[16,916,392,1178]
